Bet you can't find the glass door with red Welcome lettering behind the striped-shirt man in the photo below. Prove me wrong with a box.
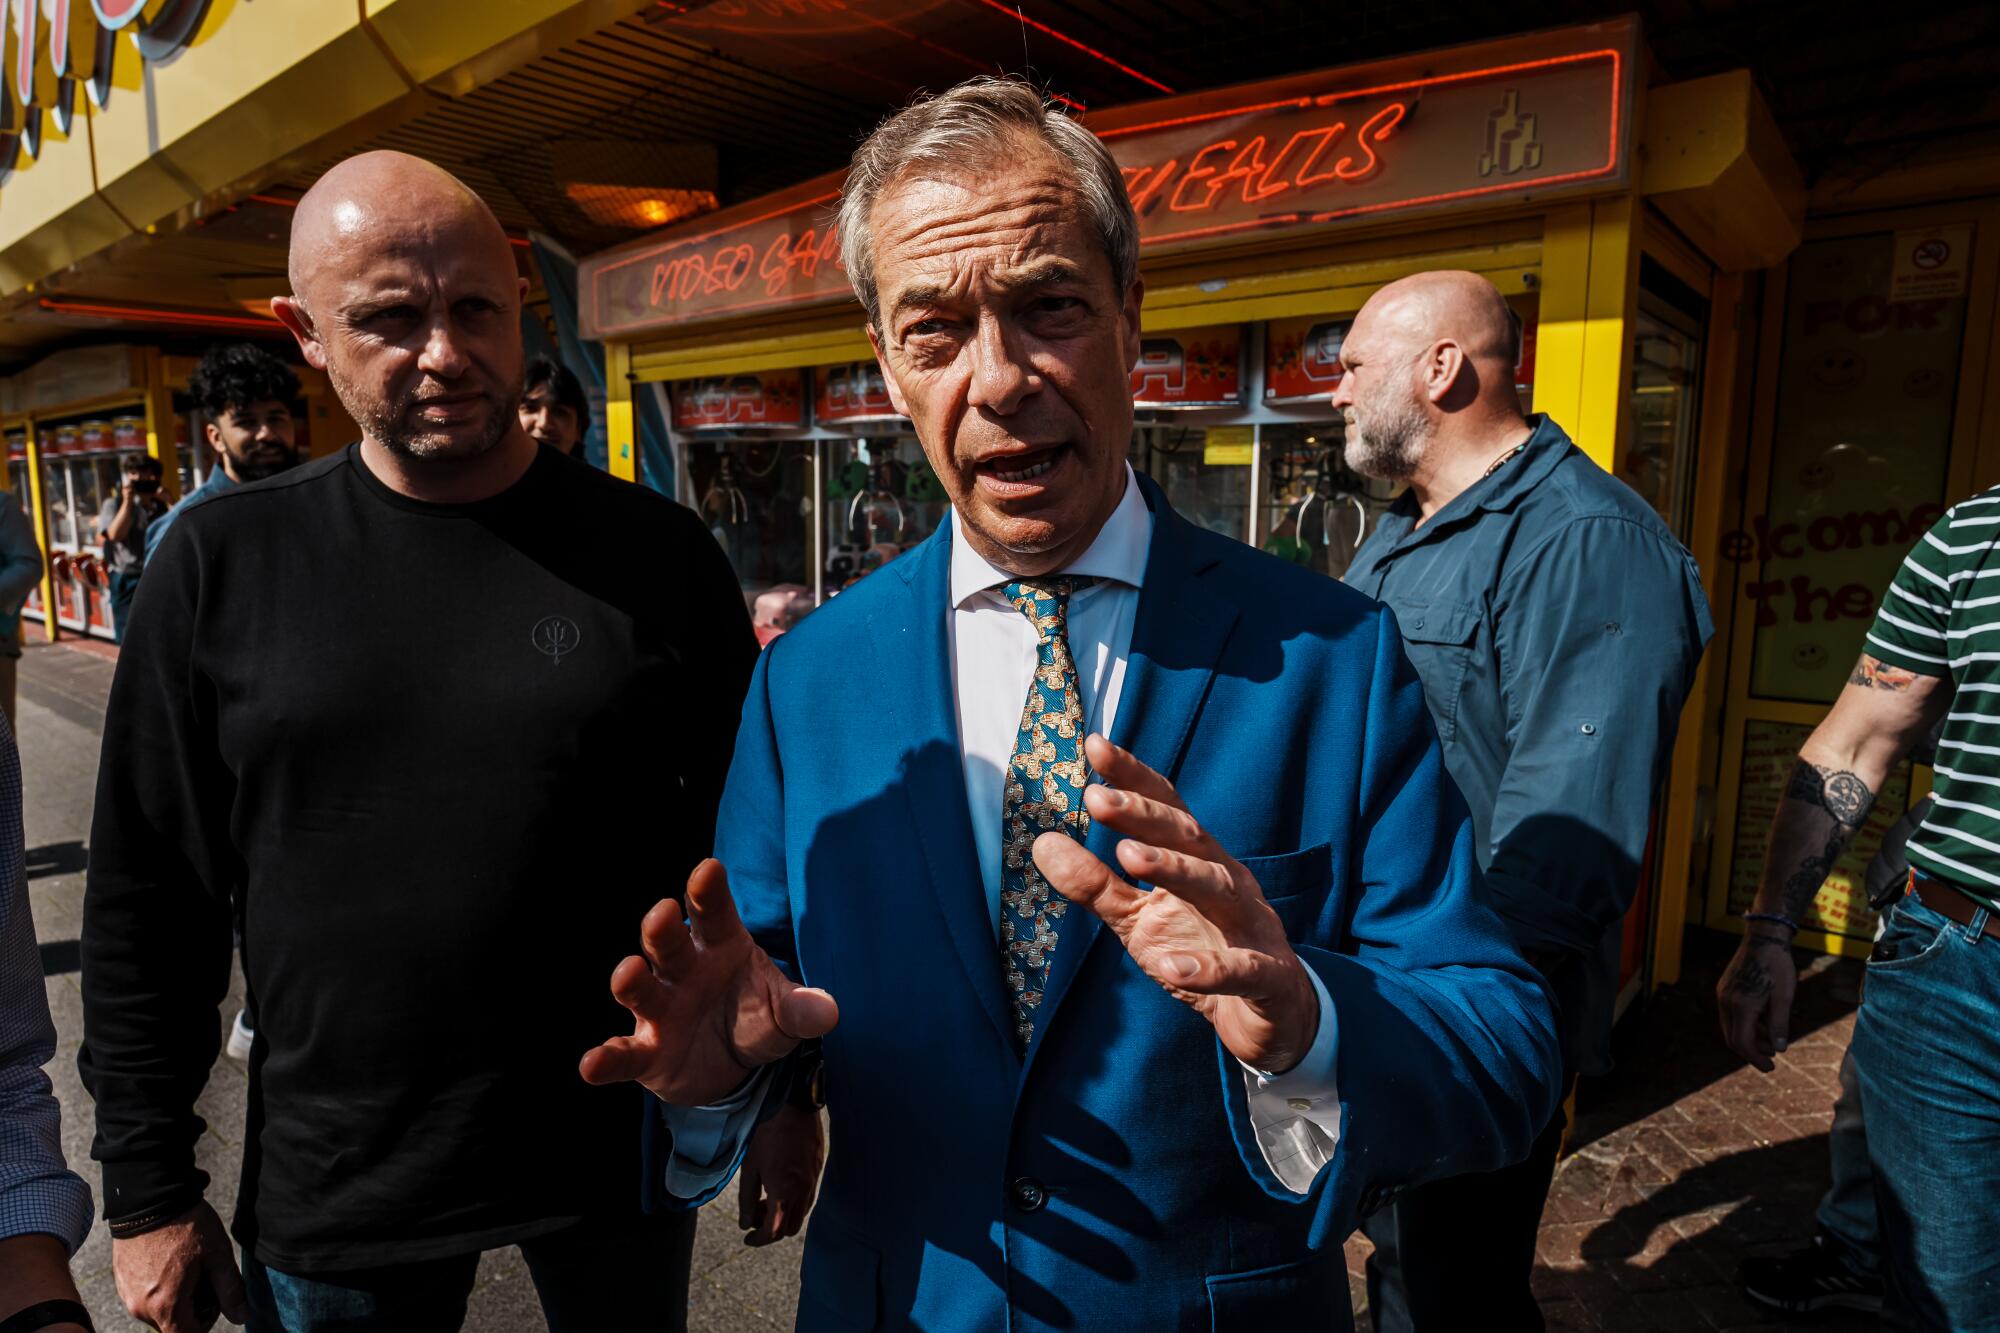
[1706,204,2000,955]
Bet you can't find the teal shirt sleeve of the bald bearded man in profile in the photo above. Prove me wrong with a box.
[1486,516,1714,955]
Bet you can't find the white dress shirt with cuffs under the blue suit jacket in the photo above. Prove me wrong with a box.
[664,466,1340,1199]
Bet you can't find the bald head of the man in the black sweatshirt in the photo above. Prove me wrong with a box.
[272,152,534,466]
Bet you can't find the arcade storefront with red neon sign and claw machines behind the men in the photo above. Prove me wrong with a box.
[580,20,2000,984]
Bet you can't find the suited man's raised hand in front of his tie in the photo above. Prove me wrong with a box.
[1034,735,1320,1073]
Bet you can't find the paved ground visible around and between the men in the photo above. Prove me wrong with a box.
[20,644,1876,1333]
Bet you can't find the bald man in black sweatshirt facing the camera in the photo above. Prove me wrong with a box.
[80,152,756,1333]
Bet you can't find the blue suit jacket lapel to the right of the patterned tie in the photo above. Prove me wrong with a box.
[1028,476,1236,1061]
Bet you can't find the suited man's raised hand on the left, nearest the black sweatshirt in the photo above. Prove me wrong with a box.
[580,859,840,1107]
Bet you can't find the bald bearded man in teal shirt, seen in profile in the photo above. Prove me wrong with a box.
[1334,272,1714,1333]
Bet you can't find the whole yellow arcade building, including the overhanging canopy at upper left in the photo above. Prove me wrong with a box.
[0,0,2000,995]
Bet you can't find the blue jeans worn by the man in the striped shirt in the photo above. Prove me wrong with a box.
[1854,897,2000,1333]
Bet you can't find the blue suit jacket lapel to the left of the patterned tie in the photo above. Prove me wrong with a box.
[868,524,1014,1053]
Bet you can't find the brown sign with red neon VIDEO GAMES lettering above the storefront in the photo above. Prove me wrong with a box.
[580,20,1638,338]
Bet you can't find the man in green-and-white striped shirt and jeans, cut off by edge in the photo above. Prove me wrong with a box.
[1718,488,2000,1333]
